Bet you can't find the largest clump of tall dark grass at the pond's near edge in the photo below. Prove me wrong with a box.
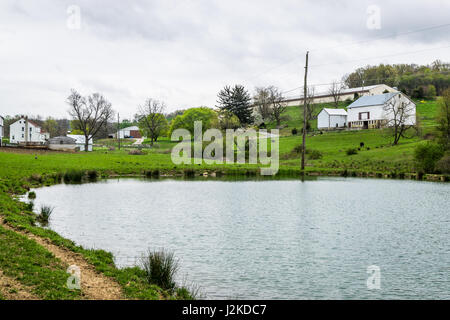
[141,249,178,293]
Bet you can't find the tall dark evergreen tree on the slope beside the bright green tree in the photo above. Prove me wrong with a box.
[217,85,254,125]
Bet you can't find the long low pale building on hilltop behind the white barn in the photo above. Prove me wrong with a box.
[284,84,398,106]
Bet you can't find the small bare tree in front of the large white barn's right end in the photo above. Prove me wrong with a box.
[383,95,417,145]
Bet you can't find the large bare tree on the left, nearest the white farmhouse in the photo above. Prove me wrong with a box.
[67,89,114,151]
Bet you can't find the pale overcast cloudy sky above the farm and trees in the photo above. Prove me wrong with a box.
[0,0,450,118]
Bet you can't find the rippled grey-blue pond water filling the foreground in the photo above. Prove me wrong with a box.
[29,178,450,299]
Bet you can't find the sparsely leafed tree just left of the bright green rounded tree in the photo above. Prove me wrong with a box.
[137,98,169,145]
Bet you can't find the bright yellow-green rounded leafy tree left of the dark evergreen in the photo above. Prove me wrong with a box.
[170,107,218,135]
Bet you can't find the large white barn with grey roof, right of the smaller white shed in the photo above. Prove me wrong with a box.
[347,92,416,129]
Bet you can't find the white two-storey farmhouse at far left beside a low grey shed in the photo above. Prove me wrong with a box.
[9,117,50,144]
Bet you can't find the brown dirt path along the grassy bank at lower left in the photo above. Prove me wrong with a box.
[0,220,124,300]
